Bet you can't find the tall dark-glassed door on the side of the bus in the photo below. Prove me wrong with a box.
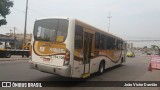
[83,32,93,78]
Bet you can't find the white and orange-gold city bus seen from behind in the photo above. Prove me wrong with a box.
[30,17,126,78]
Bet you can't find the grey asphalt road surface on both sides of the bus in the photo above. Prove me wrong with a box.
[0,54,160,90]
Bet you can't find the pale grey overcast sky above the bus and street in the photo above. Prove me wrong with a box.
[0,0,160,47]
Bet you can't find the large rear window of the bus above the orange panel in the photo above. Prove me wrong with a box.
[34,19,69,42]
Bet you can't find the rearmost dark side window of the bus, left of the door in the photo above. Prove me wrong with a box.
[74,25,83,49]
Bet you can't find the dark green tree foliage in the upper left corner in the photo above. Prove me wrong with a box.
[0,0,13,26]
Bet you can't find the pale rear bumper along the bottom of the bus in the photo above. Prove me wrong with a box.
[30,62,71,77]
